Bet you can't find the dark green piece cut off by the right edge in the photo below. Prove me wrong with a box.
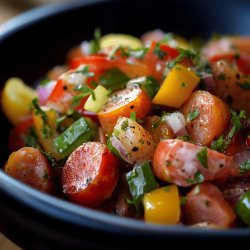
[235,191,250,227]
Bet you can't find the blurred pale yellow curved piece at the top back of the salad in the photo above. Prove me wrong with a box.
[100,34,142,49]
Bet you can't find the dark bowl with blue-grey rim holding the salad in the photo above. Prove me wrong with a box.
[0,0,250,249]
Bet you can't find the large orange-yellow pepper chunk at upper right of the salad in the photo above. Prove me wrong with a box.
[152,64,200,108]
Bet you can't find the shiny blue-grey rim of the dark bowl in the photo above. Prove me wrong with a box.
[0,0,250,238]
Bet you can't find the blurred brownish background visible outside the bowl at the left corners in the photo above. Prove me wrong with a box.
[0,0,64,250]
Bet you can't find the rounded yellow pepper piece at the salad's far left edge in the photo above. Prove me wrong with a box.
[1,78,36,125]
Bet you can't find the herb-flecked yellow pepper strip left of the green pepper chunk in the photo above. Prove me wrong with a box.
[32,107,62,160]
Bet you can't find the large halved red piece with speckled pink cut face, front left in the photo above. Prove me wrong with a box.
[62,142,119,207]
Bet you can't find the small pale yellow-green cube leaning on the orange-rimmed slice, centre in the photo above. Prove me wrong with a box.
[84,85,110,113]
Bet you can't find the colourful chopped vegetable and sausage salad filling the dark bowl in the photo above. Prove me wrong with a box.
[1,29,250,228]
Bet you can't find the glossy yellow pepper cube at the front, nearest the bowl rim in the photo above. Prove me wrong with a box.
[143,185,180,225]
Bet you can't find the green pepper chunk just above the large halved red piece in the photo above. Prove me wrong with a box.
[53,117,97,158]
